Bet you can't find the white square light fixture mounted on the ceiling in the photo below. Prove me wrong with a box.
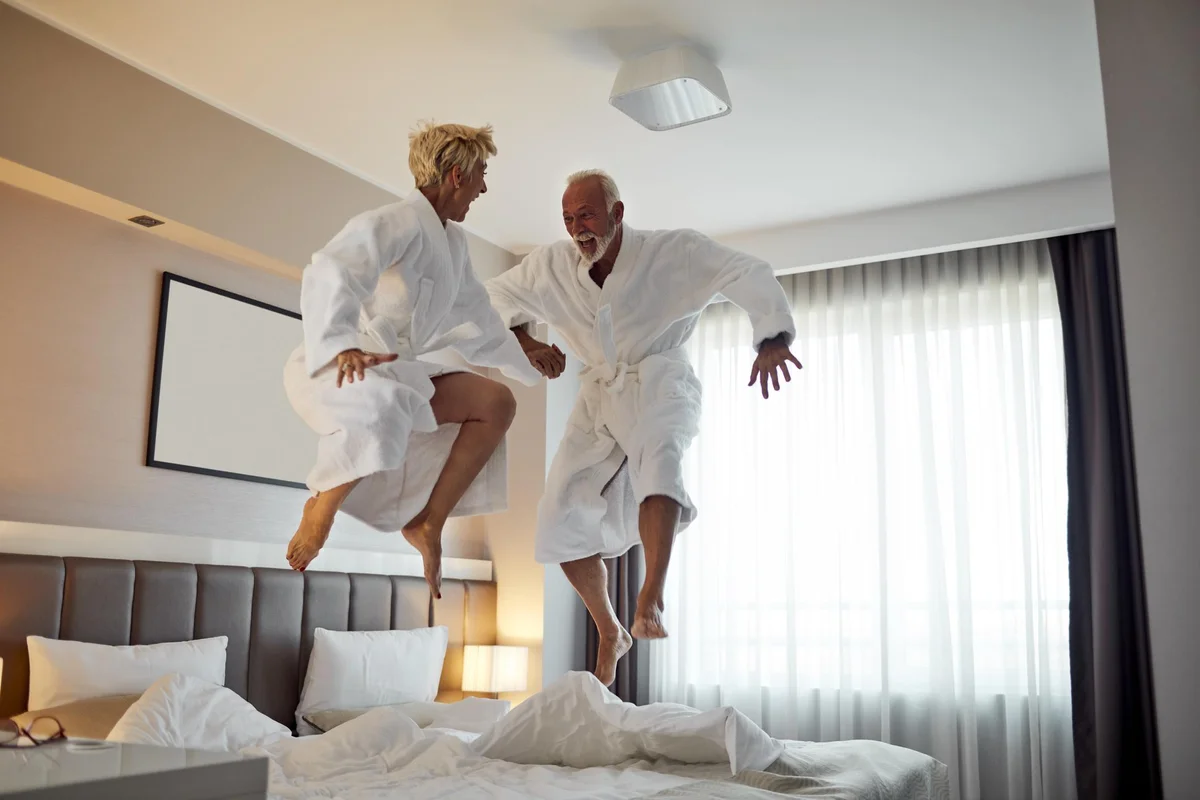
[608,46,733,131]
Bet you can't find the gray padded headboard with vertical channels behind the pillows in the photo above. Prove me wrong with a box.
[0,553,496,726]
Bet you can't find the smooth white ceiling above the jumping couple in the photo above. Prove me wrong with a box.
[7,0,1108,252]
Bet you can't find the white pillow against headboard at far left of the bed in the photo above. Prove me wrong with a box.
[25,636,229,709]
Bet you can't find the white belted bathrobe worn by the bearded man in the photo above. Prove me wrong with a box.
[486,225,796,564]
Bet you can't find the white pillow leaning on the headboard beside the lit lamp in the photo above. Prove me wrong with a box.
[296,625,450,734]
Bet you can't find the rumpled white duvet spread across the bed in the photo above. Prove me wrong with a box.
[110,673,948,800]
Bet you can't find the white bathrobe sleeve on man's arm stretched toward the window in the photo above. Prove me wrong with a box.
[680,230,796,350]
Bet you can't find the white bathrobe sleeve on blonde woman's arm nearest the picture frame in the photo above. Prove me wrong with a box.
[300,205,420,375]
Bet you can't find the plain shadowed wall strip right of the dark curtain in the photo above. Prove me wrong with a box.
[1096,0,1200,800]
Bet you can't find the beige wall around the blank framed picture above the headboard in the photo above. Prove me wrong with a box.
[0,185,487,563]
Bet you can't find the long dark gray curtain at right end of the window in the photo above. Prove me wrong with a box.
[1050,229,1163,800]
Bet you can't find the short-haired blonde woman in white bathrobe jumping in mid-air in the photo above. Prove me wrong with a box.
[284,125,540,596]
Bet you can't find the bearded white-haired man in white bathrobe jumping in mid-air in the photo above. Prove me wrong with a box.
[487,170,800,686]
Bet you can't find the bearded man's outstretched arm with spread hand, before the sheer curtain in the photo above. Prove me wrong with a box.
[688,234,803,398]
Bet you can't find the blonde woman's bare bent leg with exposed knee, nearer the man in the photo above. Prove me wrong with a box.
[403,372,517,597]
